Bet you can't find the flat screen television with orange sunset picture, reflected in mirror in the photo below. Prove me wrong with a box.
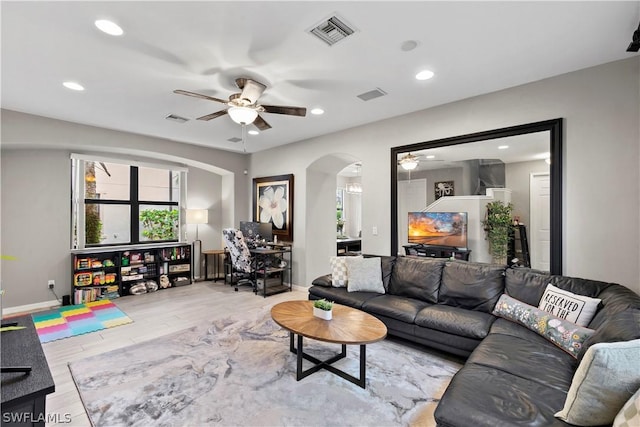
[408,212,467,249]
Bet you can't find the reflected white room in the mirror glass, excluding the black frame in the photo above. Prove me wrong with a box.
[398,132,551,270]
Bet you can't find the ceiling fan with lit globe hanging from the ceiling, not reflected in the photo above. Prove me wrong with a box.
[173,77,307,130]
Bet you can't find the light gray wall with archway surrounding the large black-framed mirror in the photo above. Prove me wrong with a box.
[251,56,640,293]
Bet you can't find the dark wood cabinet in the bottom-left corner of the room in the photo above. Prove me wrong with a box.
[1,315,55,427]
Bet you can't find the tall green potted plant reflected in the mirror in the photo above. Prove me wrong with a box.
[482,200,513,264]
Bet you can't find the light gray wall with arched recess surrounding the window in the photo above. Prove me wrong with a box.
[0,110,250,308]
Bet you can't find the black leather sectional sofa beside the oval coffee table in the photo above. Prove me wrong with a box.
[309,257,640,427]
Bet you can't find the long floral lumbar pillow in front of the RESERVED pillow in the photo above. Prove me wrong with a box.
[493,294,594,358]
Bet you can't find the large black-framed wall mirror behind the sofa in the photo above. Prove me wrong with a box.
[391,118,562,274]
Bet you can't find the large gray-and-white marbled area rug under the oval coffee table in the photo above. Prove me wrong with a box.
[69,309,461,426]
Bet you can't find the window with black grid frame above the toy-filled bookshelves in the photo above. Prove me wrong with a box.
[72,155,186,249]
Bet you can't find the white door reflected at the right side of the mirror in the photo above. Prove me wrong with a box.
[528,173,551,271]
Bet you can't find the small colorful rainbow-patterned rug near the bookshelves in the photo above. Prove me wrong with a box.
[32,300,133,343]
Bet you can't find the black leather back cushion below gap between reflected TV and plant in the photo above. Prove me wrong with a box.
[438,261,505,313]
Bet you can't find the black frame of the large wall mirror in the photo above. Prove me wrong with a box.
[391,118,563,274]
